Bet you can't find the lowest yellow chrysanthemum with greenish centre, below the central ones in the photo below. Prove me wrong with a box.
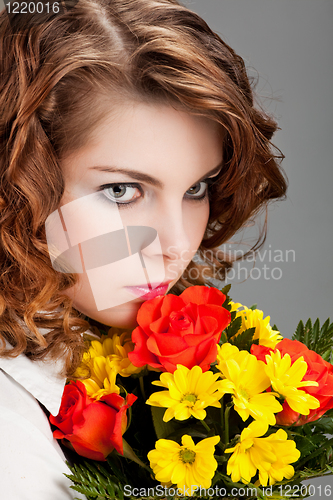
[148,434,220,495]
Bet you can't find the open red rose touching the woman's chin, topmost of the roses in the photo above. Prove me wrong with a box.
[128,286,231,373]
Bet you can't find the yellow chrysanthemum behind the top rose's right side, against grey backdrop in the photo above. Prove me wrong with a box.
[231,303,283,349]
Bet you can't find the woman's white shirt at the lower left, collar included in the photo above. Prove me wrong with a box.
[0,344,86,500]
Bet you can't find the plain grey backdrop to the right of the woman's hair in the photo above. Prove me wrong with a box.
[0,0,333,337]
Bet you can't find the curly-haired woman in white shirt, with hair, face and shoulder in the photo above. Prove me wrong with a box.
[0,0,286,500]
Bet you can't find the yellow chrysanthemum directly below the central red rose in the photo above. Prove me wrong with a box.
[147,365,223,422]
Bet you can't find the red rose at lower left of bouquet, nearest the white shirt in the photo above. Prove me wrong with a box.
[50,381,137,460]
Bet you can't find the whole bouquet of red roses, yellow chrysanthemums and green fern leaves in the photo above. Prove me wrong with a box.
[50,286,333,500]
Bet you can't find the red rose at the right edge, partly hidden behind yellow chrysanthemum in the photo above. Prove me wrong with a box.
[251,339,333,425]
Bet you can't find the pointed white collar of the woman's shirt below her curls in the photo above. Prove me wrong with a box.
[0,342,66,415]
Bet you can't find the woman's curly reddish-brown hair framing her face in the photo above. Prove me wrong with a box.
[0,0,286,373]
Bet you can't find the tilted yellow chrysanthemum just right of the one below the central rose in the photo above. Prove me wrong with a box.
[218,344,282,425]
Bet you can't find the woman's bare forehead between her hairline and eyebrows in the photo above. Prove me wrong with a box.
[63,103,223,187]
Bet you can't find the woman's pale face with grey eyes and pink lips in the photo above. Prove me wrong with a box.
[58,102,222,328]
